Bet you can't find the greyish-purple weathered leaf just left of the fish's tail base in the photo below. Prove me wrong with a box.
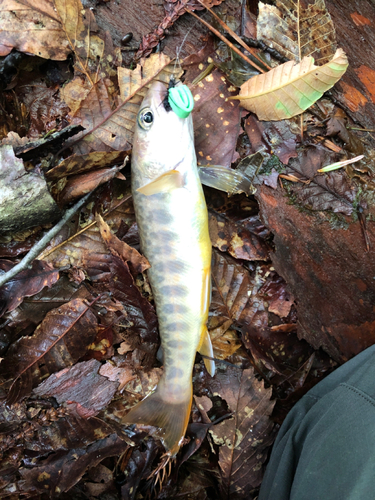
[34,359,118,418]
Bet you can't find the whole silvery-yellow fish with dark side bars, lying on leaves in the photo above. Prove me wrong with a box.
[123,82,215,457]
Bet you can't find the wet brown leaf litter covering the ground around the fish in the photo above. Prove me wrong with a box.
[0,0,374,499]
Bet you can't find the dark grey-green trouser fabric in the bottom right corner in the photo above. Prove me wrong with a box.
[259,346,375,500]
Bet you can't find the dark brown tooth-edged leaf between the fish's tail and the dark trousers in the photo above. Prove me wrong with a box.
[209,365,275,498]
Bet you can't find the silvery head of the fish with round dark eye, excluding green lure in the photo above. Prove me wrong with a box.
[132,82,196,184]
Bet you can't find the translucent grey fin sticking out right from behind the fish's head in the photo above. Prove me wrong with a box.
[198,165,256,194]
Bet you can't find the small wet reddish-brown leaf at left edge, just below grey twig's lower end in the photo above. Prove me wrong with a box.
[0,260,59,316]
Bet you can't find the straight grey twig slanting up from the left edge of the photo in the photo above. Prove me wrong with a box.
[0,192,92,292]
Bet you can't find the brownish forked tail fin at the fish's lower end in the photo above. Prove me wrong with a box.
[122,381,193,457]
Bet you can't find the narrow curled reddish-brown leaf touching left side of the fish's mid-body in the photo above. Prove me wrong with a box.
[96,214,150,274]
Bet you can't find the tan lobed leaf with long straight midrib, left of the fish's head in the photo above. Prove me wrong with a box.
[74,53,181,154]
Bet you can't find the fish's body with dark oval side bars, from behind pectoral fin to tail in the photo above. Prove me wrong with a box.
[135,181,211,403]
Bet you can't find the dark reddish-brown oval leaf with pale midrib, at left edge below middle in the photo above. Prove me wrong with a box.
[0,299,97,404]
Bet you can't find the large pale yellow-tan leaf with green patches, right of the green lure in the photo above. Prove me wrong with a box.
[232,49,348,121]
